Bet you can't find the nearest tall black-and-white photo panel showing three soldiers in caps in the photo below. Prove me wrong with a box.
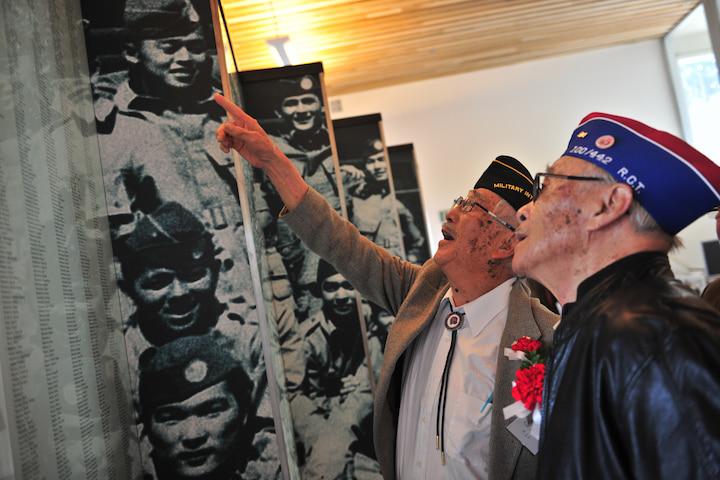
[82,0,292,480]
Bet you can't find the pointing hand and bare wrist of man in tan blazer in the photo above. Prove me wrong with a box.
[215,93,308,211]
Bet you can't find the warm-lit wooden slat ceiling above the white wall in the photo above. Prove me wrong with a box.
[222,0,699,95]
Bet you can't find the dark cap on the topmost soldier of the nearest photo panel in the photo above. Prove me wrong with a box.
[123,0,201,39]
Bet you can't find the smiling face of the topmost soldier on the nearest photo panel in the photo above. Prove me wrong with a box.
[136,30,209,89]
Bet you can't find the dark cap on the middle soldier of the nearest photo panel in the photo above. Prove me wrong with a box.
[118,202,214,267]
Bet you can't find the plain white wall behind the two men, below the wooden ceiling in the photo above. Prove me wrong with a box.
[332,40,715,284]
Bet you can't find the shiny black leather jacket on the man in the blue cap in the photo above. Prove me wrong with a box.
[538,252,720,480]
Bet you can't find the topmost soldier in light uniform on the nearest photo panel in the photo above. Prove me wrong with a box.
[85,0,252,308]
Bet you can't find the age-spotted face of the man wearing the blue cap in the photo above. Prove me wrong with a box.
[513,157,598,281]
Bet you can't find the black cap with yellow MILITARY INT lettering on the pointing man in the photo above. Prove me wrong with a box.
[475,155,533,210]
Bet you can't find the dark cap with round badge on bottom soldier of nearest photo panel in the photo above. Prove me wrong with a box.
[139,333,252,416]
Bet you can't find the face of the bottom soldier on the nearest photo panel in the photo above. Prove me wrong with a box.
[148,381,244,478]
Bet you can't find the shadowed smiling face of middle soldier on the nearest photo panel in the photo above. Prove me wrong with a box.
[132,264,217,340]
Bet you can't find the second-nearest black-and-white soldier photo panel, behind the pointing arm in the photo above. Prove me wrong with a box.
[238,64,380,478]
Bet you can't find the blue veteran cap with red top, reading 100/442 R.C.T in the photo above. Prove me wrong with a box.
[563,112,720,235]
